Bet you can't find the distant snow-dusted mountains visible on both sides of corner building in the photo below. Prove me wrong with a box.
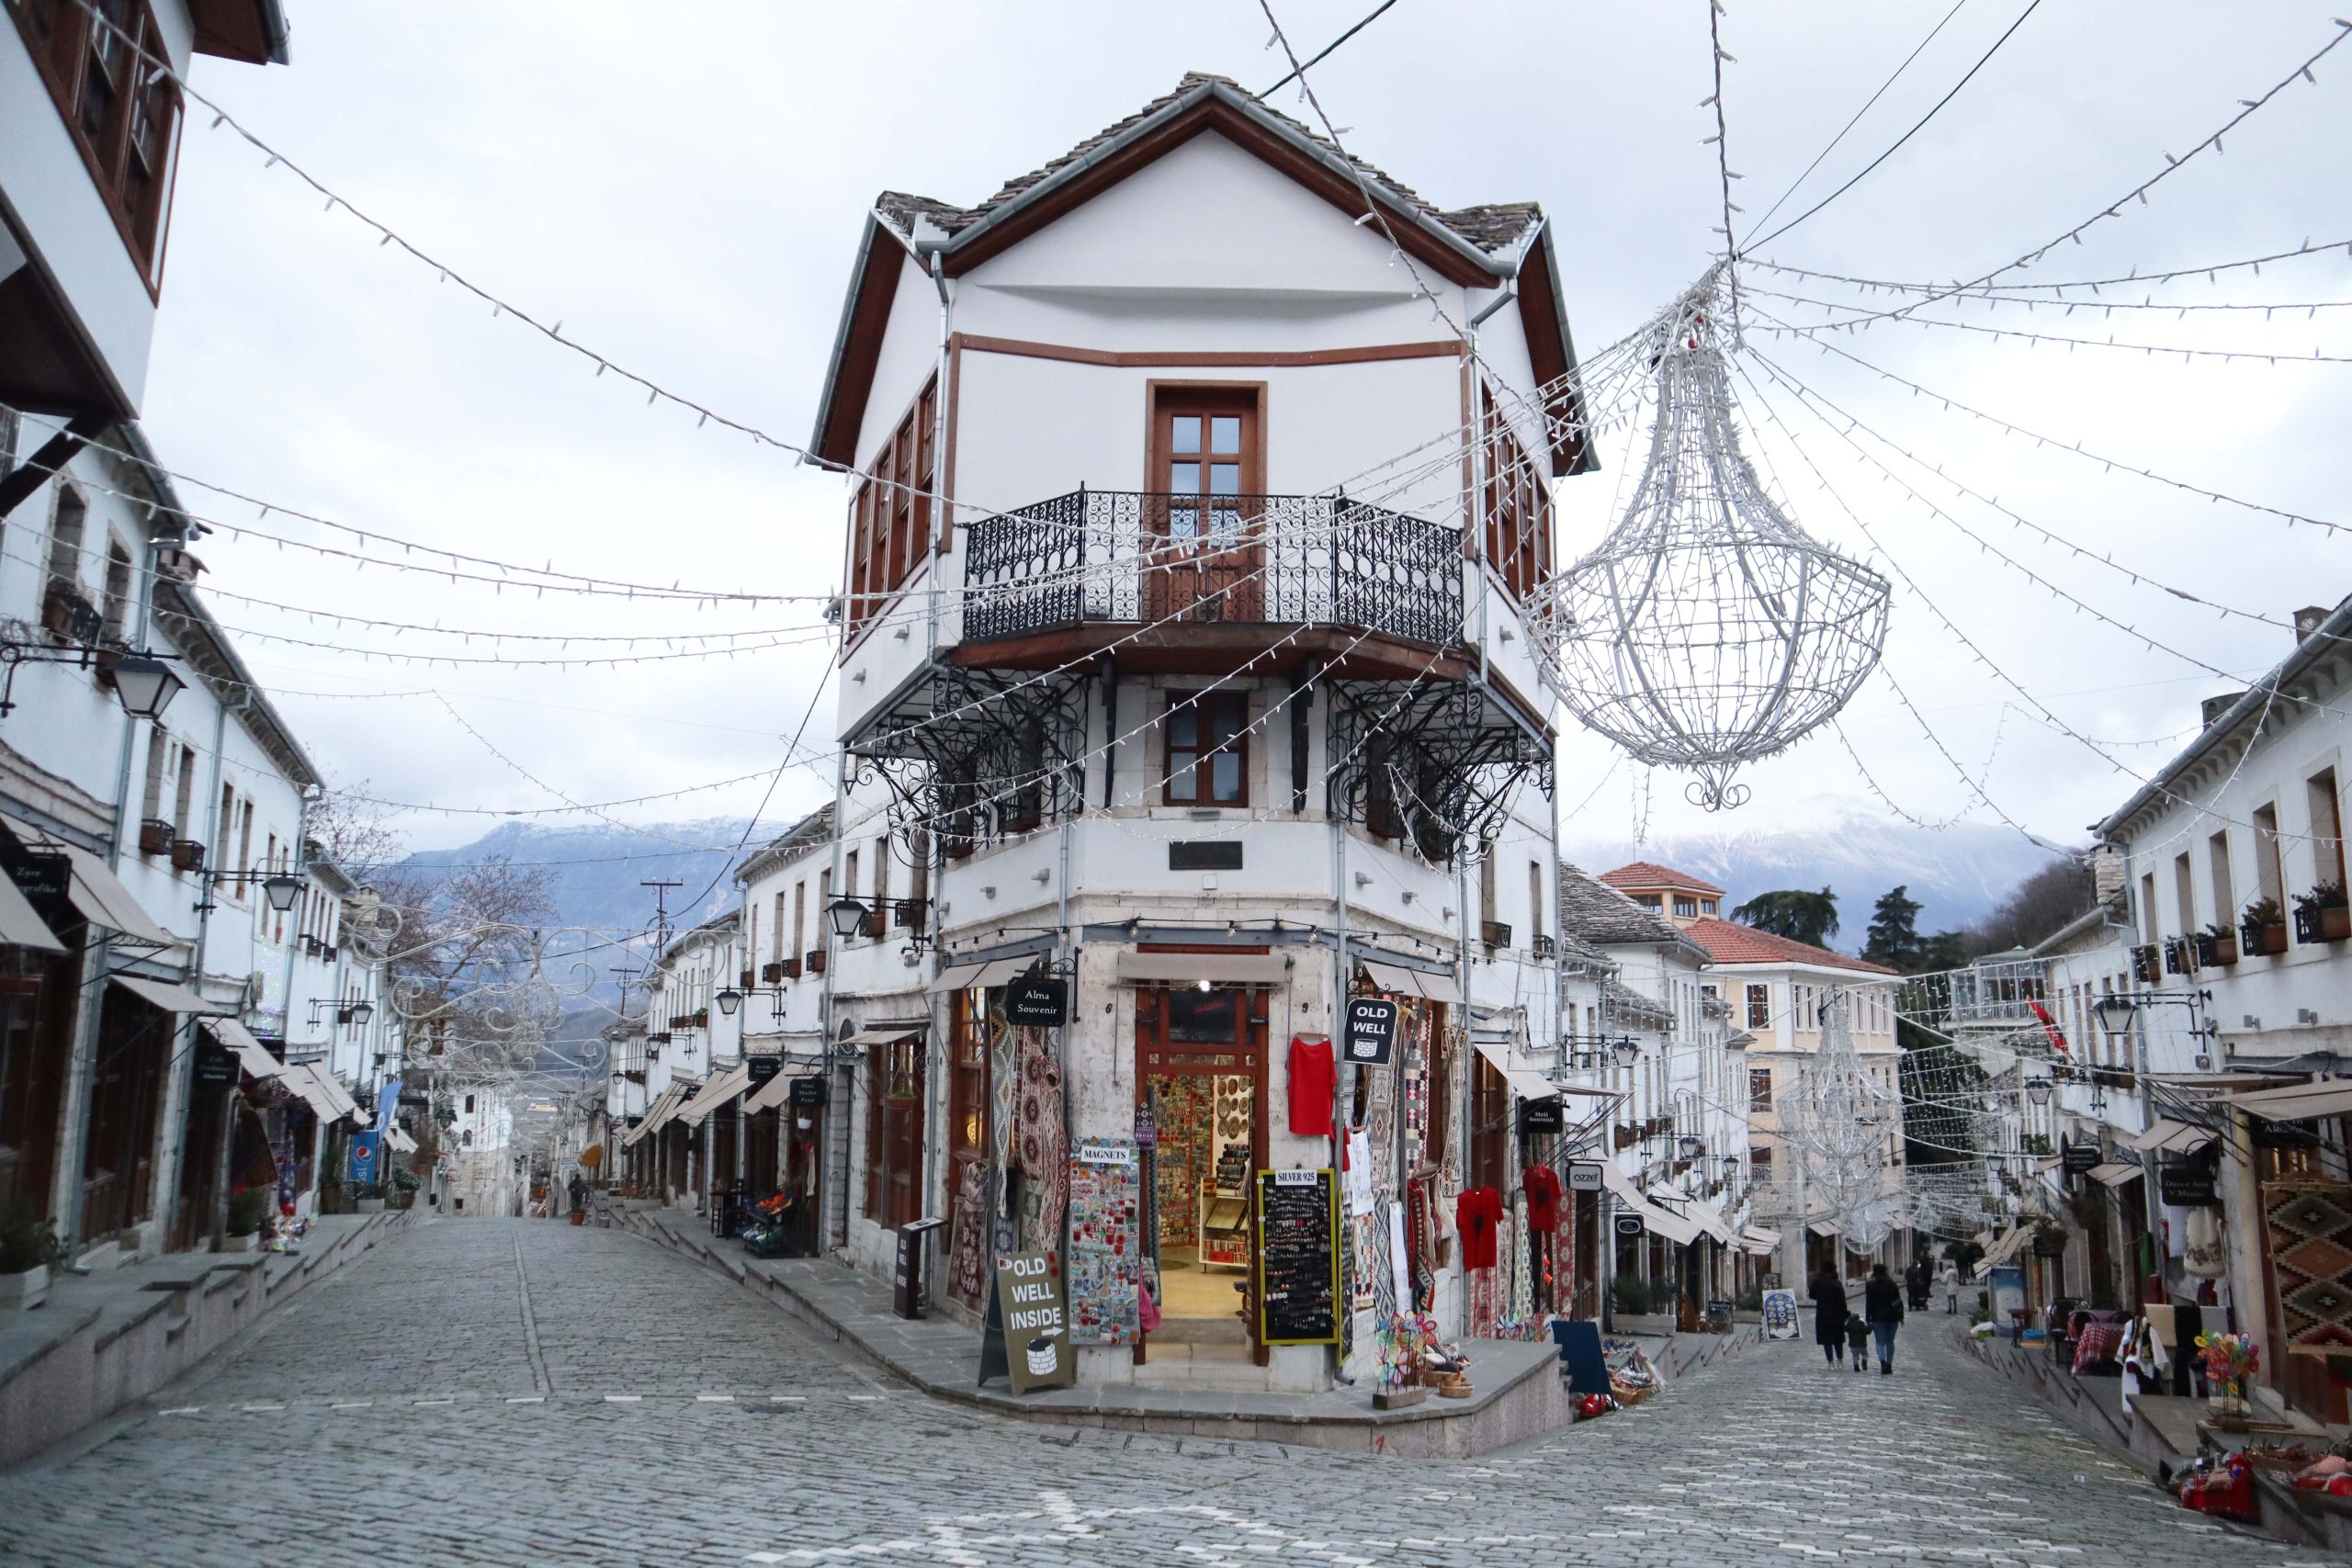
[402,795,2051,968]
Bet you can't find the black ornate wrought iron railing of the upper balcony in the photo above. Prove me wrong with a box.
[965,489,1463,647]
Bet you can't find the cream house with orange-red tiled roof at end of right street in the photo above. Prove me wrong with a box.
[1600,861,1907,1286]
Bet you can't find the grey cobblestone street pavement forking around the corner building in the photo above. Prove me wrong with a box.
[0,1220,2326,1568]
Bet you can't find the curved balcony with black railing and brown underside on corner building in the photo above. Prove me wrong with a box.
[955,489,1473,680]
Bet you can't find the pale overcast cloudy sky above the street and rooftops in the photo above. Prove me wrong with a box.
[146,0,2352,860]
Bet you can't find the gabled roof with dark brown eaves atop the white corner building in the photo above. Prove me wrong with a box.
[809,71,1590,475]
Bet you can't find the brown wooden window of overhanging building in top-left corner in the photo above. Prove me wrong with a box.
[9,0,179,289]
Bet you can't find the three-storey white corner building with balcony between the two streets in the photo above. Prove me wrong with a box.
[795,75,1590,1389]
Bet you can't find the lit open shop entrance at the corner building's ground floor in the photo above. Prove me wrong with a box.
[1136,987,1265,1363]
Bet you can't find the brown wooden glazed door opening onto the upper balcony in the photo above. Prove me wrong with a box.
[1143,386,1265,621]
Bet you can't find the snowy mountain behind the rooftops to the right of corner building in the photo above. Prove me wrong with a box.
[1562,795,2053,952]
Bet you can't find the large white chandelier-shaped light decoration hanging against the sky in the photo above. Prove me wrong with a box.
[1538,264,1886,811]
